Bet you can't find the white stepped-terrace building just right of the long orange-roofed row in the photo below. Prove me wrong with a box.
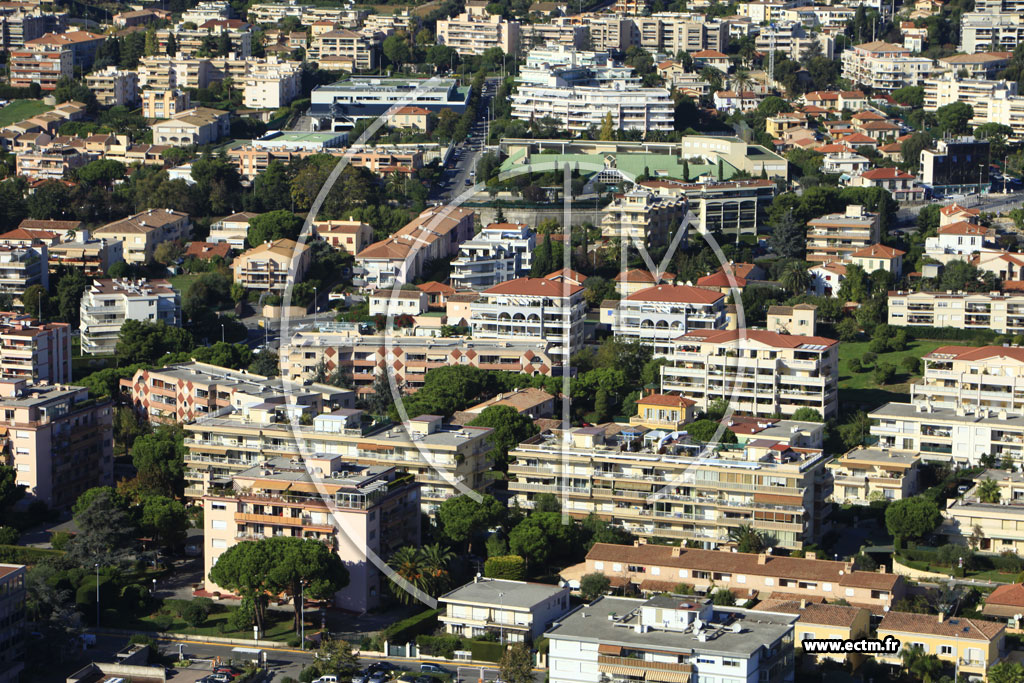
[451,223,537,290]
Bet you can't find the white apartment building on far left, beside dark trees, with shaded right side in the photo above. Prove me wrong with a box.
[81,279,181,355]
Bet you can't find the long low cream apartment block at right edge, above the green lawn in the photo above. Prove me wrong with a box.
[889,291,1024,335]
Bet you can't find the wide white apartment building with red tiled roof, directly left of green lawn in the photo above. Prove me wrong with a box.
[662,329,839,419]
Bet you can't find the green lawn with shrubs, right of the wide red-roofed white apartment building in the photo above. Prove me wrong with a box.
[839,340,948,412]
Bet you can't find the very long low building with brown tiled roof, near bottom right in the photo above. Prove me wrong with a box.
[586,542,906,611]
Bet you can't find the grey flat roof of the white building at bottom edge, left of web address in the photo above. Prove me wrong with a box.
[545,596,797,657]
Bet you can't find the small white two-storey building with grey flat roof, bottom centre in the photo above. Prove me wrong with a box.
[437,575,571,643]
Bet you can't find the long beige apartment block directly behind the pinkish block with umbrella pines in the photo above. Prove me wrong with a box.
[184,403,492,514]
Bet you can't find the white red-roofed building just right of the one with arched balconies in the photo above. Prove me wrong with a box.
[601,285,727,357]
